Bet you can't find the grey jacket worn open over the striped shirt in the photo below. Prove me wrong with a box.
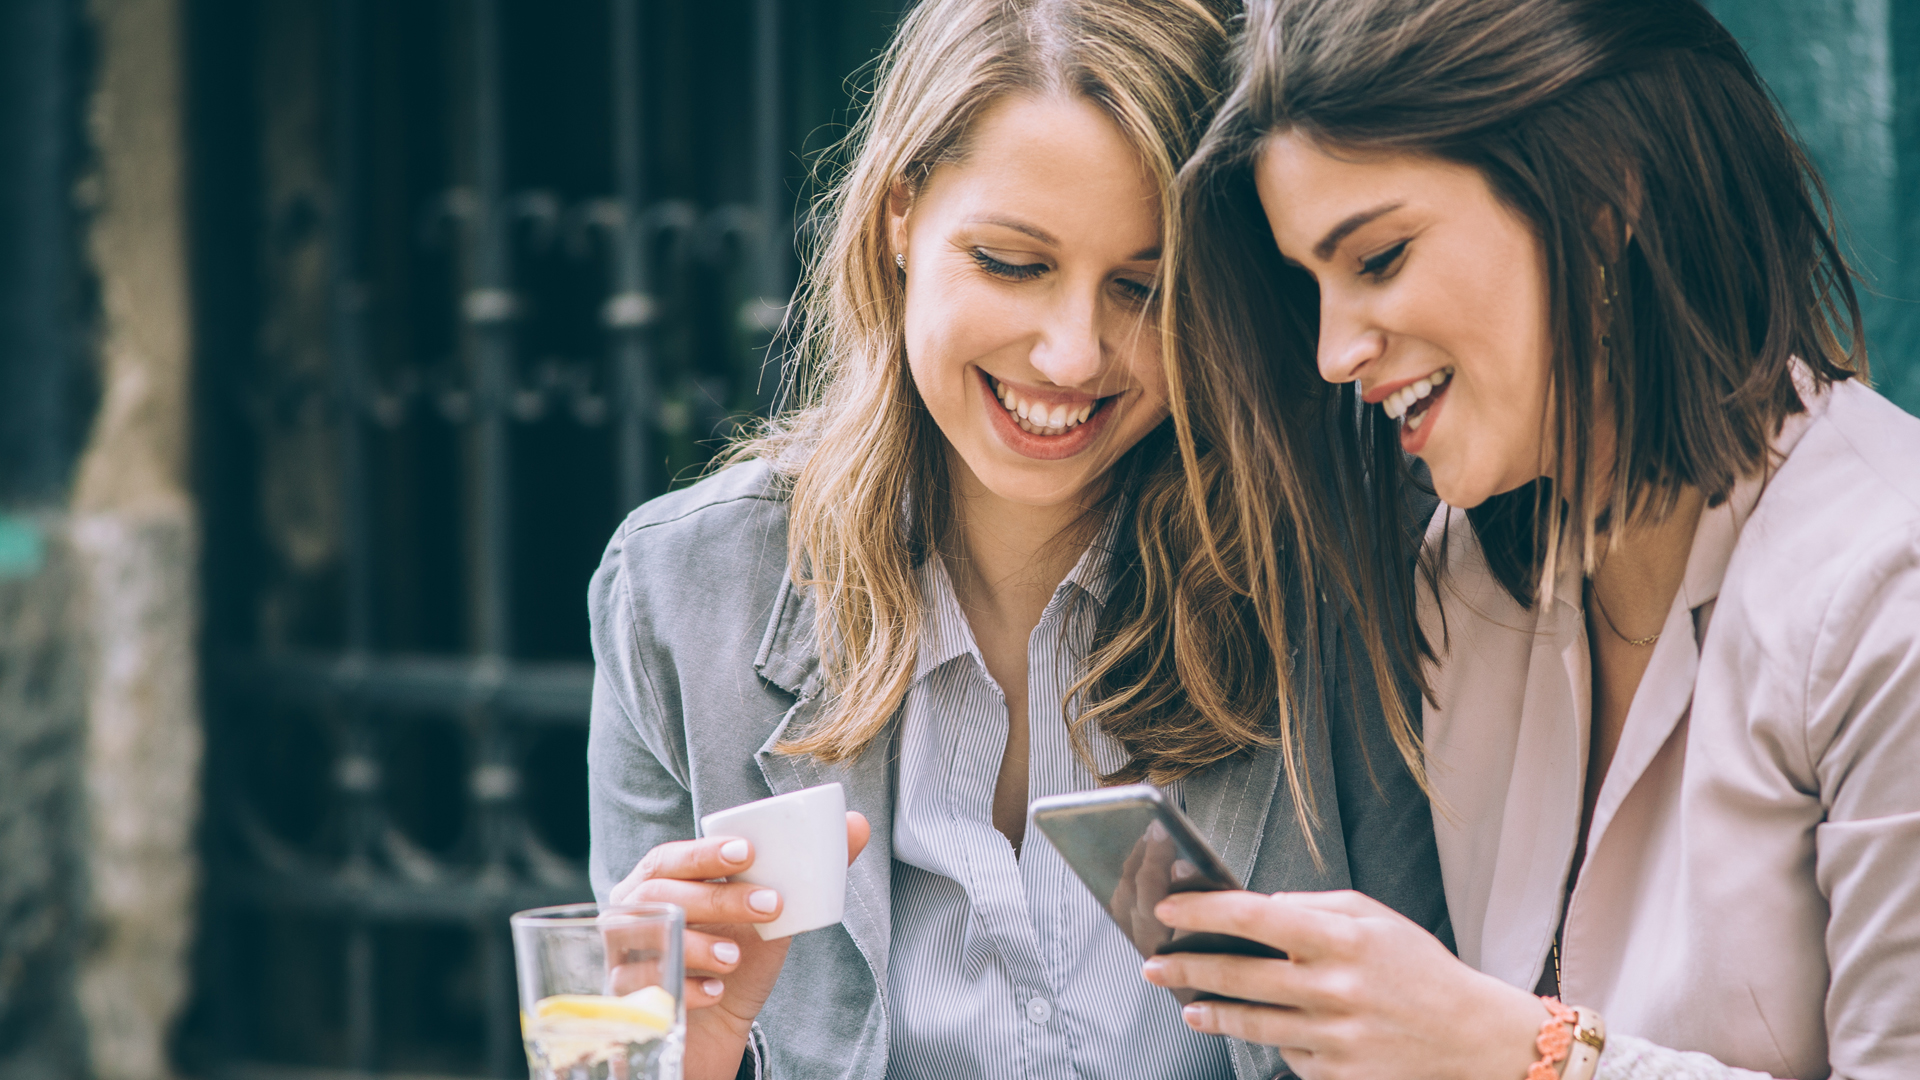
[588,461,1452,1080]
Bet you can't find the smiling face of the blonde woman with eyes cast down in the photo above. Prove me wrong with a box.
[889,96,1167,505]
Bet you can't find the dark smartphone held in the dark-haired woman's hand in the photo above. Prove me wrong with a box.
[1027,784,1286,1005]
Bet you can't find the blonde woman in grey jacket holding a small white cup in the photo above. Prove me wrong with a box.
[589,0,1446,1080]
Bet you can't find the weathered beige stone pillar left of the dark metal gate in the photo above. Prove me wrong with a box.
[71,0,202,1080]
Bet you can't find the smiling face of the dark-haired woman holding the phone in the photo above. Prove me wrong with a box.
[1254,133,1551,507]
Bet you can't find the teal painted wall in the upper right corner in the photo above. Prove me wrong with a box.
[1707,0,1920,413]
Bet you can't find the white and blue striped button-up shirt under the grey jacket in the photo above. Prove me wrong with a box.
[887,521,1233,1080]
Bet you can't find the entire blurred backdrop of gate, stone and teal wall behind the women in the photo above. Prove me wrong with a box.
[0,0,1920,1080]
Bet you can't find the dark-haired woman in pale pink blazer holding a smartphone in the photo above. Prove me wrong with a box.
[1148,0,1920,1080]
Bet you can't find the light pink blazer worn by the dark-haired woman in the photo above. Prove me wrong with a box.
[1421,372,1920,1080]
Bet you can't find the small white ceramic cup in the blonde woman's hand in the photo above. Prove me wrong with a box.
[701,784,847,942]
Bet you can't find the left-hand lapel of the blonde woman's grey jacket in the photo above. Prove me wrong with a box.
[755,578,893,988]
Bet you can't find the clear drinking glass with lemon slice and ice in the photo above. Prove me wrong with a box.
[511,903,687,1080]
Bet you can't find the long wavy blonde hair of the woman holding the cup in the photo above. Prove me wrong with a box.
[726,0,1405,836]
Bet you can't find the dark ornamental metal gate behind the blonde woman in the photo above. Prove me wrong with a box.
[182,0,897,1078]
